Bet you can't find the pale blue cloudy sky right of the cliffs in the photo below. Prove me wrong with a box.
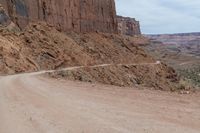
[115,0,200,34]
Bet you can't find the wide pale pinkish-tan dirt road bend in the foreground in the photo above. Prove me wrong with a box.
[0,66,200,133]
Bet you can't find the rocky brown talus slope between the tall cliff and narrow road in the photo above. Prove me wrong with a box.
[0,23,151,73]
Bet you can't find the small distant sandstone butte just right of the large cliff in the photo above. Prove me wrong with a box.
[117,16,141,36]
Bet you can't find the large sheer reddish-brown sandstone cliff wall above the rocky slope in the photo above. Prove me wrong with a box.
[0,0,117,33]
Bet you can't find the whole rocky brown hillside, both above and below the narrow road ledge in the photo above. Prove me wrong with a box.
[0,22,178,90]
